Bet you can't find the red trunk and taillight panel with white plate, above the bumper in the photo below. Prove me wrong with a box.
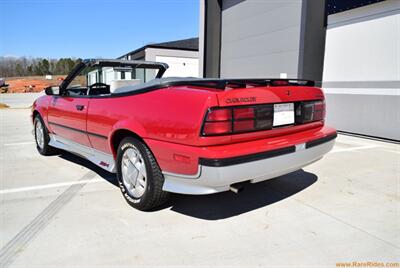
[198,80,325,141]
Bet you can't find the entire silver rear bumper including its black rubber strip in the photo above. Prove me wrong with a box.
[163,133,336,195]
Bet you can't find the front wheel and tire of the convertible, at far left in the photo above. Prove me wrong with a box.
[33,115,58,156]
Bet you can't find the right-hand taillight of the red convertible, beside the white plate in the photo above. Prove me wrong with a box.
[295,100,325,124]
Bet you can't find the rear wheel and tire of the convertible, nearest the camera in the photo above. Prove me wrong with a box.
[117,137,169,211]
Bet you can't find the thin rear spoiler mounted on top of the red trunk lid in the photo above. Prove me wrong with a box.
[170,79,315,89]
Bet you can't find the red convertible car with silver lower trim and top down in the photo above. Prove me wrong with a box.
[32,60,336,210]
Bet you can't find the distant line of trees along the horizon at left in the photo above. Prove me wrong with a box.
[0,57,82,77]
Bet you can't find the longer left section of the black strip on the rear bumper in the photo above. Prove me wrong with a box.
[199,146,296,167]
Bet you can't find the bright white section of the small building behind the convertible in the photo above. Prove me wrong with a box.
[156,56,199,77]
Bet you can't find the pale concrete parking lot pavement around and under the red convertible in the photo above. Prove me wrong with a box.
[0,109,400,267]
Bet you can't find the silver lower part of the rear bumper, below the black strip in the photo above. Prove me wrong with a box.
[163,140,335,195]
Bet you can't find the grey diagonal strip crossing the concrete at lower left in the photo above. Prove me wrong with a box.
[0,171,96,268]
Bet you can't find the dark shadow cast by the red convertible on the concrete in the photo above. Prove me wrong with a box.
[58,151,318,221]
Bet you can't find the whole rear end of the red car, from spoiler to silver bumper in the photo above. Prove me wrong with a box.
[157,80,336,197]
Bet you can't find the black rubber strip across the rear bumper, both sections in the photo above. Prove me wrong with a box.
[199,133,337,167]
